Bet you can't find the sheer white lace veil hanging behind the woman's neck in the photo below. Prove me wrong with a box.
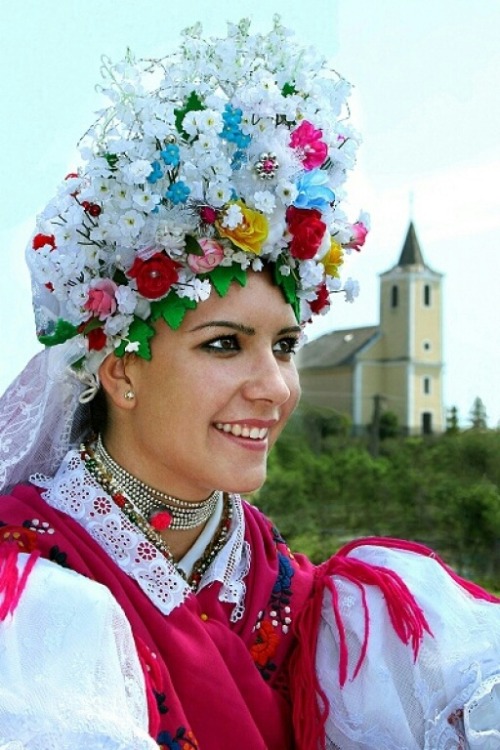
[0,341,94,491]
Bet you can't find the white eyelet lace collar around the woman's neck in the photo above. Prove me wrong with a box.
[31,450,250,622]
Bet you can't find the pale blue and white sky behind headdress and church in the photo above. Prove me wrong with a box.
[0,0,500,426]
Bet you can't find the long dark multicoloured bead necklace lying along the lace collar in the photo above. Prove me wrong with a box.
[80,443,233,591]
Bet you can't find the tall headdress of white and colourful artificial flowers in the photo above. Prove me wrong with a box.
[27,17,367,372]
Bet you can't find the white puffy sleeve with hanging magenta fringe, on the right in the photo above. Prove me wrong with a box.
[316,545,500,750]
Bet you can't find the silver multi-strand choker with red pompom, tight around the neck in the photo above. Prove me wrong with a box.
[94,435,222,531]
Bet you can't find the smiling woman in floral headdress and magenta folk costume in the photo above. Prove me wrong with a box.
[0,21,500,750]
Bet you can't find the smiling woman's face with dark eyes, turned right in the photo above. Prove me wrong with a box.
[106,273,300,500]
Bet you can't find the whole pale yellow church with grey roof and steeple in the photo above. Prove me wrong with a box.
[298,223,445,434]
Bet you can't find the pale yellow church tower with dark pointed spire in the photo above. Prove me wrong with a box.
[379,223,445,434]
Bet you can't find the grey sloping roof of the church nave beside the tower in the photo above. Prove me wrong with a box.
[297,326,380,370]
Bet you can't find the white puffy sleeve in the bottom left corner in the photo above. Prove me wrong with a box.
[0,554,157,750]
